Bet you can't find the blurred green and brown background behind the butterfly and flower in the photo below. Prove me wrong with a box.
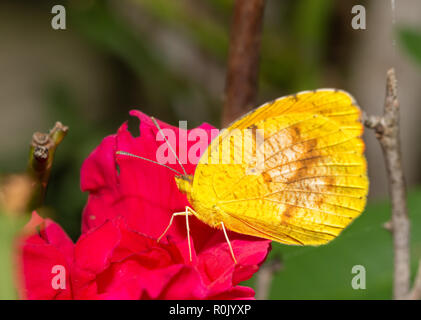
[0,0,421,299]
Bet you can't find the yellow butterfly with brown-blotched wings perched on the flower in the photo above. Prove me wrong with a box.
[116,89,368,262]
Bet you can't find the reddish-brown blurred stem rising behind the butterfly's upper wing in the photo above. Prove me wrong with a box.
[222,0,265,126]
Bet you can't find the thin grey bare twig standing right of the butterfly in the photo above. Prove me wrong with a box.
[363,69,410,299]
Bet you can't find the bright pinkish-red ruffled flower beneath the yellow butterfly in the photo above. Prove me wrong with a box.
[19,111,270,299]
